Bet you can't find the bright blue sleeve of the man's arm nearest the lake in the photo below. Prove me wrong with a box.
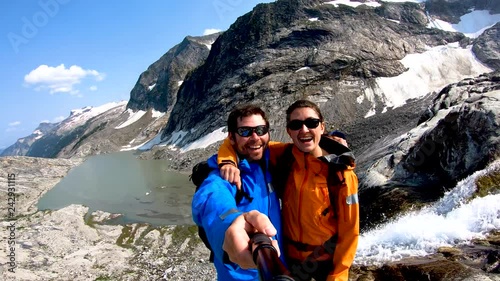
[191,170,242,261]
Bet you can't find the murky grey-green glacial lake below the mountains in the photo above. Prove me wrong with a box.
[37,151,195,225]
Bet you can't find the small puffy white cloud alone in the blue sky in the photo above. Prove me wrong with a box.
[24,64,105,94]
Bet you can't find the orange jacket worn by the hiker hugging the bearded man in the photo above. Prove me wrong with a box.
[218,139,359,281]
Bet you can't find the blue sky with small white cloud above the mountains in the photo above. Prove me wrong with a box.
[0,0,273,149]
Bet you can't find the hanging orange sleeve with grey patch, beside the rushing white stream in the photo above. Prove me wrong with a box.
[327,168,359,281]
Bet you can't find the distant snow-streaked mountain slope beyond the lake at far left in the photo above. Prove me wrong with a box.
[2,101,165,158]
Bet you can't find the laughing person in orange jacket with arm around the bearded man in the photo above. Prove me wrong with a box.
[218,100,359,281]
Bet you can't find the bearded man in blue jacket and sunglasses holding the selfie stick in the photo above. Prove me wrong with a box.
[192,105,281,280]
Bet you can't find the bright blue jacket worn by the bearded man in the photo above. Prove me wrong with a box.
[192,149,282,280]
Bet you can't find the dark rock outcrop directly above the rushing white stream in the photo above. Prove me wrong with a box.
[357,71,500,231]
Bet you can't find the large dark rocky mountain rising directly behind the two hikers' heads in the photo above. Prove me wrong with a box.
[162,0,499,146]
